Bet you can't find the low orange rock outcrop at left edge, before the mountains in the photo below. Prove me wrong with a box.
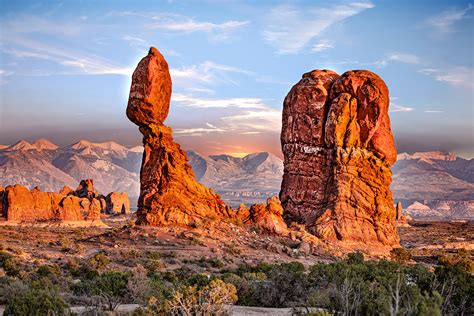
[0,179,130,222]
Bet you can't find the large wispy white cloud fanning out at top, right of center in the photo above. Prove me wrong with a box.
[262,2,374,54]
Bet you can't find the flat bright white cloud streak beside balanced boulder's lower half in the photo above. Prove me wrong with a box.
[171,93,266,109]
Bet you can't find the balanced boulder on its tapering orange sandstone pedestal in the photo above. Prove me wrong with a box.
[127,47,231,225]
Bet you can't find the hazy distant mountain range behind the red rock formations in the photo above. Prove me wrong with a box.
[0,139,474,219]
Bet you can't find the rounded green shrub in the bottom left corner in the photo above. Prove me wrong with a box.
[4,278,68,315]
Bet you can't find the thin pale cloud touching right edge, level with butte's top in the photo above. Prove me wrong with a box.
[418,66,474,88]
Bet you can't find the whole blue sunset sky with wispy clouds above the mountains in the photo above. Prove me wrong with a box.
[0,0,474,157]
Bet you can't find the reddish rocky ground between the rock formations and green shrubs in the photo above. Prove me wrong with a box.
[0,214,474,273]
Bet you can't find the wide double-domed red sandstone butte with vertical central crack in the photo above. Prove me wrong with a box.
[280,70,399,246]
